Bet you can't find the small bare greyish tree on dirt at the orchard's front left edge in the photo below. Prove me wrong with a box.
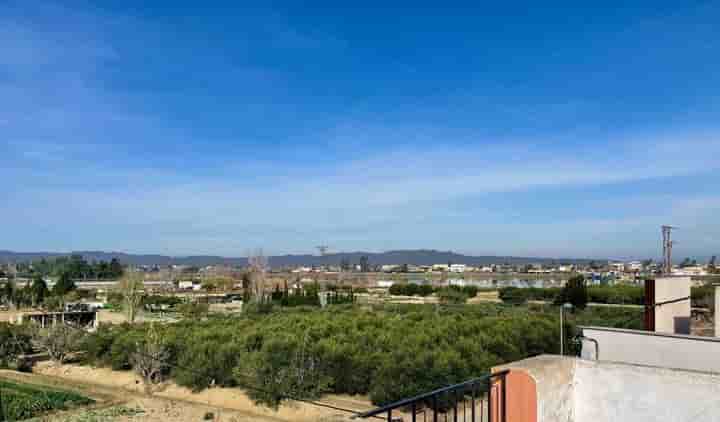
[131,324,170,395]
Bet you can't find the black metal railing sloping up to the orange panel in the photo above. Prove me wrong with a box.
[356,370,509,422]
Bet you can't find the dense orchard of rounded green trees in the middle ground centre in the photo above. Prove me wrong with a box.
[77,304,642,407]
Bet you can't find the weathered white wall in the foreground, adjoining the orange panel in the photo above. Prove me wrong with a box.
[494,355,720,422]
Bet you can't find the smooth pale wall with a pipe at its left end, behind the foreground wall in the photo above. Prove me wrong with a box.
[581,327,720,373]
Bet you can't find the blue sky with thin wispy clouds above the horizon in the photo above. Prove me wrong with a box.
[0,0,720,258]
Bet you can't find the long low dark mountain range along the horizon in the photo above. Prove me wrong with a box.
[0,249,591,268]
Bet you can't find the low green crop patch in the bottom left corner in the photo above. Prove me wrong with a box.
[0,379,94,421]
